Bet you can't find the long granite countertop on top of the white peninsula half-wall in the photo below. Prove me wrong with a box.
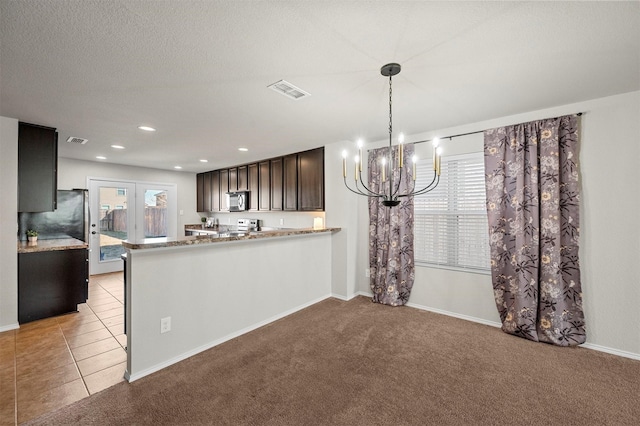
[122,228,340,250]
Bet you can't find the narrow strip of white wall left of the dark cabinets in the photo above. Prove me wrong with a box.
[0,117,18,332]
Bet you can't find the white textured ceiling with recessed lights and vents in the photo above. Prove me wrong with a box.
[0,0,640,171]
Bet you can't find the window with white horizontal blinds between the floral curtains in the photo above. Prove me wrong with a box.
[414,152,490,273]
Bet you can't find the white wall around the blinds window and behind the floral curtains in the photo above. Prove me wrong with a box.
[325,92,640,358]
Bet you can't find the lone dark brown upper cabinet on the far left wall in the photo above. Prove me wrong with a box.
[18,123,58,212]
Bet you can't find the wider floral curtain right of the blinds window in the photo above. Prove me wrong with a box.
[484,116,586,346]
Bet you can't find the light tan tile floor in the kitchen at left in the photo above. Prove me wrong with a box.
[0,272,127,426]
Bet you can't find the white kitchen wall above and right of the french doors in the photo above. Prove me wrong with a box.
[58,158,200,231]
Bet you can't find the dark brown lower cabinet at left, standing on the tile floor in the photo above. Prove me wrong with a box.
[18,249,89,324]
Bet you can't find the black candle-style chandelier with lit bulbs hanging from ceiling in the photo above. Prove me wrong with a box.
[342,63,442,207]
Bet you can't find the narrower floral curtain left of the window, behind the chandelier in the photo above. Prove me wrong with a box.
[368,144,415,306]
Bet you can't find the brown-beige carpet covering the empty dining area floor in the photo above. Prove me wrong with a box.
[30,297,640,425]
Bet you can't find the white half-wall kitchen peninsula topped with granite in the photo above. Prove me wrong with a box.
[123,228,340,381]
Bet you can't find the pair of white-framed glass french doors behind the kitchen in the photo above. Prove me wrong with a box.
[88,178,177,275]
